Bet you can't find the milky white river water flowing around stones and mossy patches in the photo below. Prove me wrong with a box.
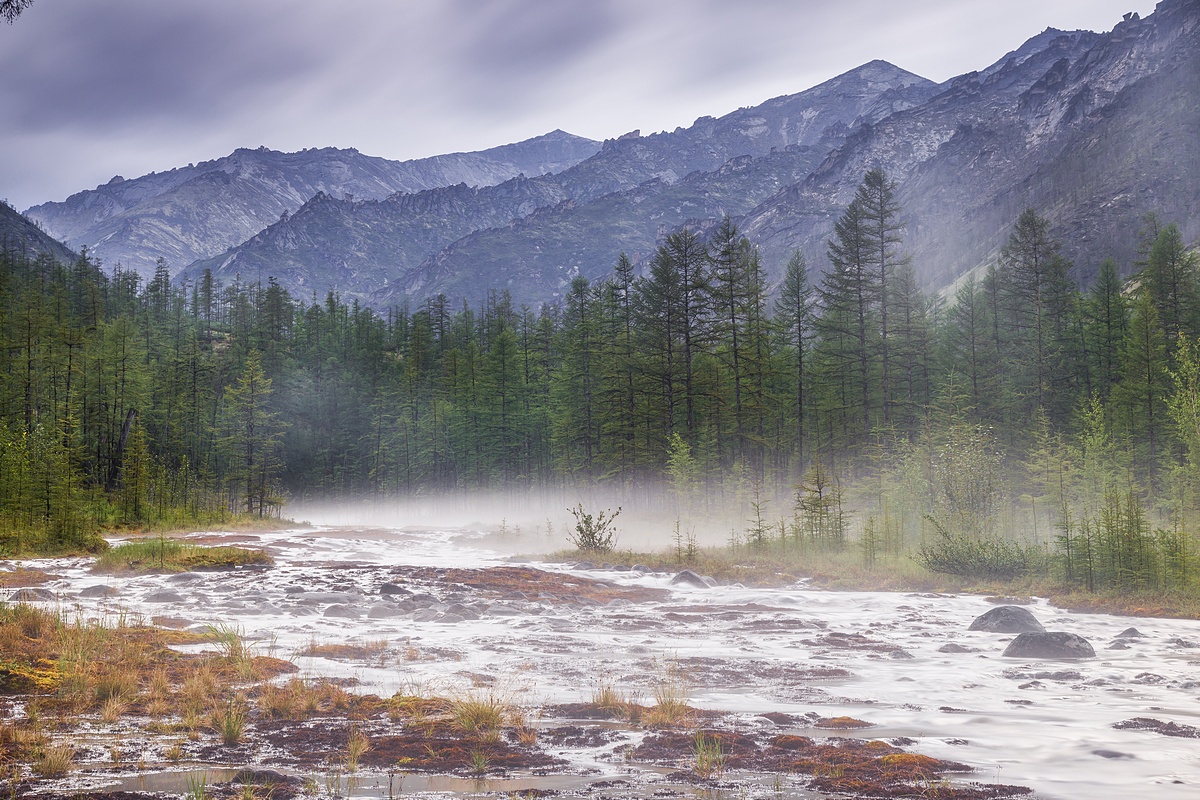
[9,528,1200,800]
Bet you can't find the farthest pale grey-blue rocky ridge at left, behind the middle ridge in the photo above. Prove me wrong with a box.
[25,131,609,273]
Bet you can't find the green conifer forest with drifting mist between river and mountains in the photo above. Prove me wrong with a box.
[0,170,1200,594]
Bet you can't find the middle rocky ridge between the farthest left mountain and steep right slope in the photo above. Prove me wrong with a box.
[184,61,936,305]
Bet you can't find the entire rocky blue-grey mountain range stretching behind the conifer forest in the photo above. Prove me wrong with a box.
[18,0,1200,308]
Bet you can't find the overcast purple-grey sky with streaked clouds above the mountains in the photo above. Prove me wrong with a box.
[0,0,1154,209]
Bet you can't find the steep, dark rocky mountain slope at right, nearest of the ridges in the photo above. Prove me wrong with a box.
[743,0,1200,288]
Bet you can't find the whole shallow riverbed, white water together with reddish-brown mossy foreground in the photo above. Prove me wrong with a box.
[0,527,1200,800]
